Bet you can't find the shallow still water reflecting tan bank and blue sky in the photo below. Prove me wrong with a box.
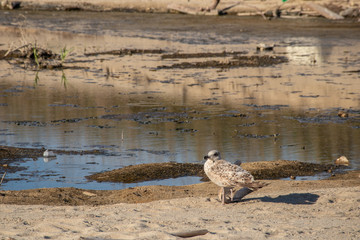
[0,11,360,190]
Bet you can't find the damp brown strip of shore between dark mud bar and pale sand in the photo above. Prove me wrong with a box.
[0,171,360,206]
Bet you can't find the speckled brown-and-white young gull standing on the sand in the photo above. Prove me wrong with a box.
[204,150,265,204]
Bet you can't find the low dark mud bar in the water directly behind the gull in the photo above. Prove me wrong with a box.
[87,160,340,183]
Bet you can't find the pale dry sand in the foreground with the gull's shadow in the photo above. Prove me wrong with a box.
[0,171,360,239]
